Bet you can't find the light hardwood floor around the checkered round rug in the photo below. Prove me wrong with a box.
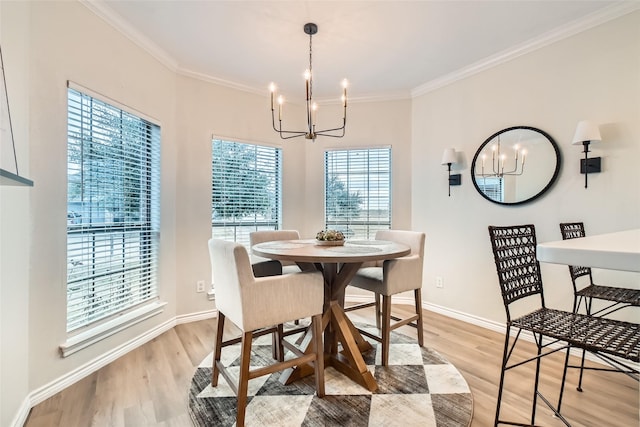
[25,306,640,427]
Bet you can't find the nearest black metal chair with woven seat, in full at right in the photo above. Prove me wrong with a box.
[489,225,640,426]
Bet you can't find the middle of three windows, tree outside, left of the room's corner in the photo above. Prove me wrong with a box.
[211,139,282,245]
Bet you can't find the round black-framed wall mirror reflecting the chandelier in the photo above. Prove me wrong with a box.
[471,126,560,205]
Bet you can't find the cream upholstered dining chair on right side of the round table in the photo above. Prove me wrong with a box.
[345,230,425,366]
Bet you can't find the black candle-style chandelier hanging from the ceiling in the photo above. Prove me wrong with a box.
[269,23,347,141]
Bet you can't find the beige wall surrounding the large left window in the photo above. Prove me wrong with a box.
[23,2,178,404]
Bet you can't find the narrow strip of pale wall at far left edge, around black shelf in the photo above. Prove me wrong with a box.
[0,2,32,426]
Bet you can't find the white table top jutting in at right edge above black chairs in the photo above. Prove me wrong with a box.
[537,229,640,272]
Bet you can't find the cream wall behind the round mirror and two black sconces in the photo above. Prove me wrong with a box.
[411,12,640,324]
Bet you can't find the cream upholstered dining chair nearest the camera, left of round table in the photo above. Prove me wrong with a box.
[209,239,324,426]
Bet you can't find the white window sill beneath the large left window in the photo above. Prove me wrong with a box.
[60,301,167,357]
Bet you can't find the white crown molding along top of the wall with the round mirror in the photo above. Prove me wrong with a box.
[411,1,640,98]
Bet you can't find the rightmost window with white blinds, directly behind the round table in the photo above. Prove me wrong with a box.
[324,148,391,239]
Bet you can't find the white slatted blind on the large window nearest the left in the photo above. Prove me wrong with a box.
[67,88,160,332]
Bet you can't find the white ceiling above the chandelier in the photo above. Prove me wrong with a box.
[84,0,640,101]
